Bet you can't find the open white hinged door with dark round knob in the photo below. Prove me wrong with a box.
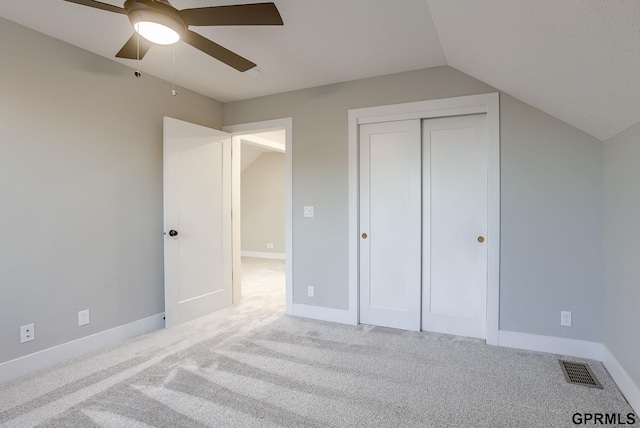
[164,117,232,327]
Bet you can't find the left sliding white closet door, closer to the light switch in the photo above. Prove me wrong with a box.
[360,120,421,330]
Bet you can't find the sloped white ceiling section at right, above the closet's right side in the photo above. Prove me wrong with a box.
[427,0,640,140]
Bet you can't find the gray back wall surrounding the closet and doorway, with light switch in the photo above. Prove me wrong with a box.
[224,67,603,341]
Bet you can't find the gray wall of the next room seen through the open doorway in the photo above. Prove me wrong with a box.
[240,152,286,254]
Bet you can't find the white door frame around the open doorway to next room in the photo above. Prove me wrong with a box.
[222,117,293,315]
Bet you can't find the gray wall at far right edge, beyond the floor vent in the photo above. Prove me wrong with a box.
[604,124,640,385]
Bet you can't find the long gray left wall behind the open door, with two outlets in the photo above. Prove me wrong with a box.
[0,19,222,362]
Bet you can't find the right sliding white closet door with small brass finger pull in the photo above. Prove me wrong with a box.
[422,114,491,338]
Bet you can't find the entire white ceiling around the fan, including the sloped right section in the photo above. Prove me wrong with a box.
[0,0,640,139]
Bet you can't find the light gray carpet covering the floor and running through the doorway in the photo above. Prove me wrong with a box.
[0,258,637,427]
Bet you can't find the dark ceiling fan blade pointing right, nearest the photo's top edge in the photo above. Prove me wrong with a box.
[180,3,283,27]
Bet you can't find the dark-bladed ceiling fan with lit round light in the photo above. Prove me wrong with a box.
[65,0,283,71]
